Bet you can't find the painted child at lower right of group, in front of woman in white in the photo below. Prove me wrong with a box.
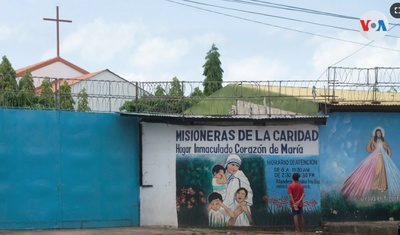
[228,188,253,226]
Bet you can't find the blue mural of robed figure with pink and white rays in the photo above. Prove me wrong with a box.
[321,113,400,221]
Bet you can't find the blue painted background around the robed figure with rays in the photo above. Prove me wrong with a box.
[320,112,400,221]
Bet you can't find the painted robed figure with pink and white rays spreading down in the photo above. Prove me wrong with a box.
[341,127,400,199]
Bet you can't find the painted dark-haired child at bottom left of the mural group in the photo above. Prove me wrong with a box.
[207,192,235,227]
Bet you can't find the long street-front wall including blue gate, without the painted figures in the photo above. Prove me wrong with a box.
[0,109,400,229]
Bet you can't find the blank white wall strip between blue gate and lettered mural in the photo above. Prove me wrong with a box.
[140,123,178,227]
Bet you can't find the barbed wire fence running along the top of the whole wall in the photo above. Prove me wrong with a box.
[0,67,400,116]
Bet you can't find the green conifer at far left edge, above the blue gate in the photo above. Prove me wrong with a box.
[0,56,17,107]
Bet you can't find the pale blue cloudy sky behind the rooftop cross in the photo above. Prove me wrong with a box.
[0,0,400,81]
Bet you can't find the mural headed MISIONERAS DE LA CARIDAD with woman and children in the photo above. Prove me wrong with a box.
[174,125,321,227]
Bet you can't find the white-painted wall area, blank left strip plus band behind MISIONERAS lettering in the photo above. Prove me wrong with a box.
[140,122,319,227]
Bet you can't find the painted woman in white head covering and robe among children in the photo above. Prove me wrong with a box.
[224,154,253,225]
